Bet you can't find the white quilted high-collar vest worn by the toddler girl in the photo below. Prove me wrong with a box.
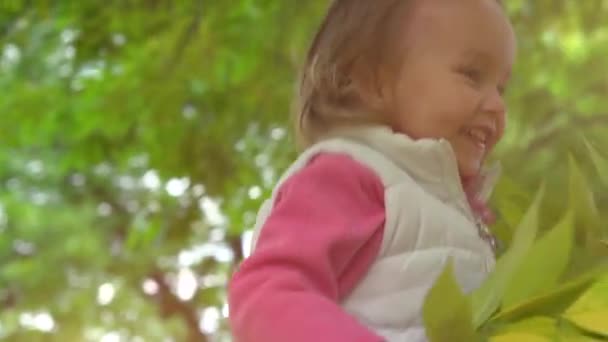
[252,127,497,342]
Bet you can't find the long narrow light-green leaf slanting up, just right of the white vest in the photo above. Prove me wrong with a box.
[471,184,545,328]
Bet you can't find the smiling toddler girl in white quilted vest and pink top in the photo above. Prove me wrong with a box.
[229,0,515,342]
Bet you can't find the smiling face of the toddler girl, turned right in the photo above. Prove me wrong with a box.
[390,0,515,179]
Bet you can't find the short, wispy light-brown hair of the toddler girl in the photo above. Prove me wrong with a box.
[294,0,410,147]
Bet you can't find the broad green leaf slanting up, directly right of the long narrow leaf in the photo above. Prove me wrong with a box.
[502,212,574,307]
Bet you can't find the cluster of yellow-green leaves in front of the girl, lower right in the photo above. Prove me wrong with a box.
[423,159,608,342]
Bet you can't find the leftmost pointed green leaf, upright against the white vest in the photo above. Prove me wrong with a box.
[423,259,478,342]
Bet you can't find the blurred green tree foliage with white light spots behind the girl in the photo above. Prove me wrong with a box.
[0,0,608,342]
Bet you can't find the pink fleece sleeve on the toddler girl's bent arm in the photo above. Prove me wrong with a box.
[228,154,385,342]
